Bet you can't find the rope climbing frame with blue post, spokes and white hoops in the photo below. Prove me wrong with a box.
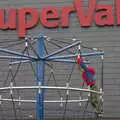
[0,35,104,120]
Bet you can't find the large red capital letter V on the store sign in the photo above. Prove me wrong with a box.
[74,0,96,27]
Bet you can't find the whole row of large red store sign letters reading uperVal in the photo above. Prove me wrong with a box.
[0,0,120,37]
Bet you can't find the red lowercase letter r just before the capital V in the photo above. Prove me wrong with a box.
[61,6,76,27]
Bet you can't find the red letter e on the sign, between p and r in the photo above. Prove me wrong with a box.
[40,7,59,28]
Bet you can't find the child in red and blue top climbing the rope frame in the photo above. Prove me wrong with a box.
[77,56,100,113]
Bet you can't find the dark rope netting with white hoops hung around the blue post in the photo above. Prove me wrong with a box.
[0,36,103,120]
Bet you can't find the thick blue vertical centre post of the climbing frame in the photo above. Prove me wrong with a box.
[36,35,45,120]
